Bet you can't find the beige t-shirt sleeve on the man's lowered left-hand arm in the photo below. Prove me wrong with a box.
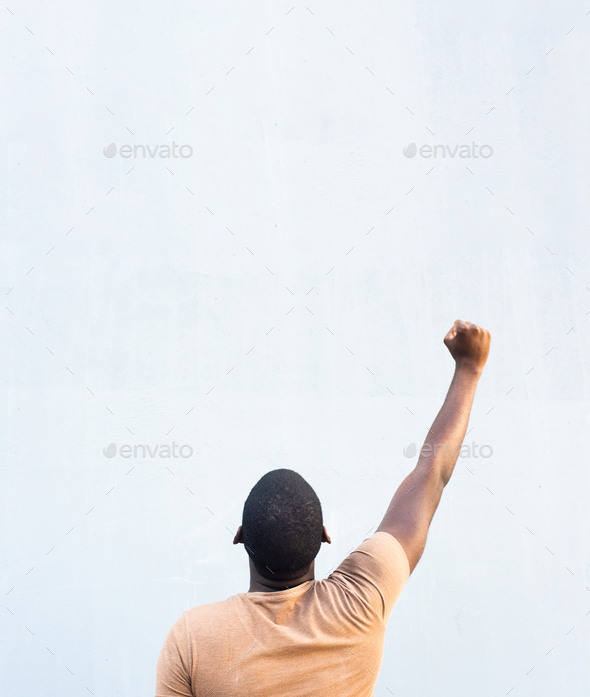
[155,614,193,697]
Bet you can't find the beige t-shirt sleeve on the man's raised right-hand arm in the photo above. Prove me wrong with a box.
[329,531,410,624]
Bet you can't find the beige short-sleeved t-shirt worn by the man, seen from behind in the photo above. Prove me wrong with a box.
[156,532,410,697]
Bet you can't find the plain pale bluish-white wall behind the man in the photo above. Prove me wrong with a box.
[0,0,590,697]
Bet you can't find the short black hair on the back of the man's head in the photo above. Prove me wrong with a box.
[242,469,323,581]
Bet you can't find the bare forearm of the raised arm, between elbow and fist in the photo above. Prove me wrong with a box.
[416,364,481,486]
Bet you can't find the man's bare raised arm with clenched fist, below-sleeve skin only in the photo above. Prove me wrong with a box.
[377,319,490,573]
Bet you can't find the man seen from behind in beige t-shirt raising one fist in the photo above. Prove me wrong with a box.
[156,320,490,697]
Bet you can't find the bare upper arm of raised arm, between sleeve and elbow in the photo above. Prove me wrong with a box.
[377,467,444,573]
